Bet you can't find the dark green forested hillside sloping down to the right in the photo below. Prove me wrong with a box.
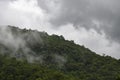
[0,27,120,80]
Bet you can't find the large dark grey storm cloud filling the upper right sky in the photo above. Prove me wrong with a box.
[42,0,120,42]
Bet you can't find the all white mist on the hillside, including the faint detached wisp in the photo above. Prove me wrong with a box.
[0,26,67,68]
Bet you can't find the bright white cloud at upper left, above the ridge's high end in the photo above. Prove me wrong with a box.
[0,0,49,29]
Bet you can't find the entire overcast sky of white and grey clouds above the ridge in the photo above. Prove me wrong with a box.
[0,0,120,58]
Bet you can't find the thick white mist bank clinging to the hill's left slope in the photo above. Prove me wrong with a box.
[0,26,42,63]
